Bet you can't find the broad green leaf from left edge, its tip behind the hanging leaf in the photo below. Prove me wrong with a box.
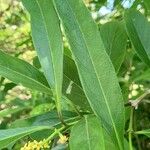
[0,51,52,94]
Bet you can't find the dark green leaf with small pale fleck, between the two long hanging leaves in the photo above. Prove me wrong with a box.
[63,55,91,110]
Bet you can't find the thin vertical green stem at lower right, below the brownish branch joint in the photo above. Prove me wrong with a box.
[128,107,134,150]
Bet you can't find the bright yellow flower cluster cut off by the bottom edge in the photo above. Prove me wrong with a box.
[20,139,50,150]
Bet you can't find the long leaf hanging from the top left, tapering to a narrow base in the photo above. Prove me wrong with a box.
[22,0,63,109]
